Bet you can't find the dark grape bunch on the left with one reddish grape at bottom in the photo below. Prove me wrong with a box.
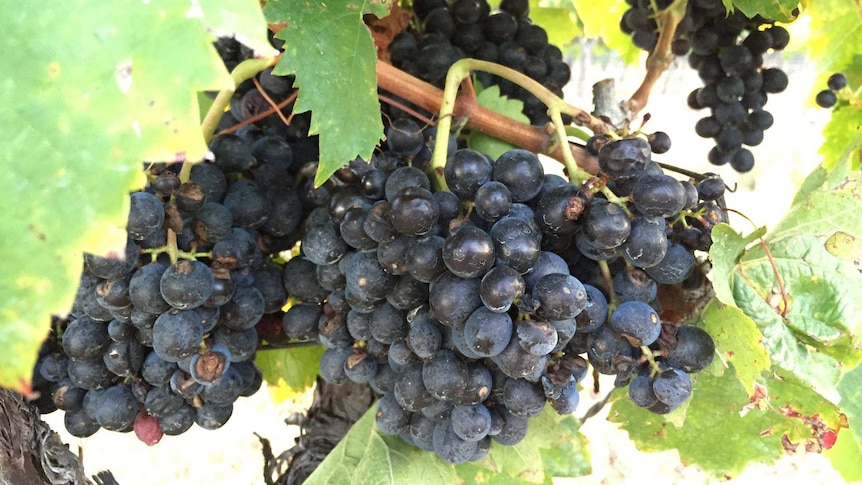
[27,118,330,444]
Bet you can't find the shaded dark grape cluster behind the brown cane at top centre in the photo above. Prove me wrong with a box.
[389,0,571,125]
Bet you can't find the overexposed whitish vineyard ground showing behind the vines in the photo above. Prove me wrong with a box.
[45,53,845,485]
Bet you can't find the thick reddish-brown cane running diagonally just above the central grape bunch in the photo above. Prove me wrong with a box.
[377,60,598,173]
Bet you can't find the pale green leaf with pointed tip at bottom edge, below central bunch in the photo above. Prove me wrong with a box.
[305,406,455,485]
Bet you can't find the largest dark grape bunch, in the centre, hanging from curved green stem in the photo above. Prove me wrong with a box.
[266,108,724,463]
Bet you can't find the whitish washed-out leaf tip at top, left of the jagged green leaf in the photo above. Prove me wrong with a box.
[199,0,277,57]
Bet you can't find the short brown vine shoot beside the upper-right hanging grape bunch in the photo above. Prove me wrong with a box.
[626,0,688,120]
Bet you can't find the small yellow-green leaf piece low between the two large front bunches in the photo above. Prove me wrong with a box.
[255,345,326,401]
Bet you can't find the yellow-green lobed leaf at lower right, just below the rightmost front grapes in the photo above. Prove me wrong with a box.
[608,366,784,478]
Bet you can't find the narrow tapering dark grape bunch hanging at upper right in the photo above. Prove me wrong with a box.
[621,0,790,173]
